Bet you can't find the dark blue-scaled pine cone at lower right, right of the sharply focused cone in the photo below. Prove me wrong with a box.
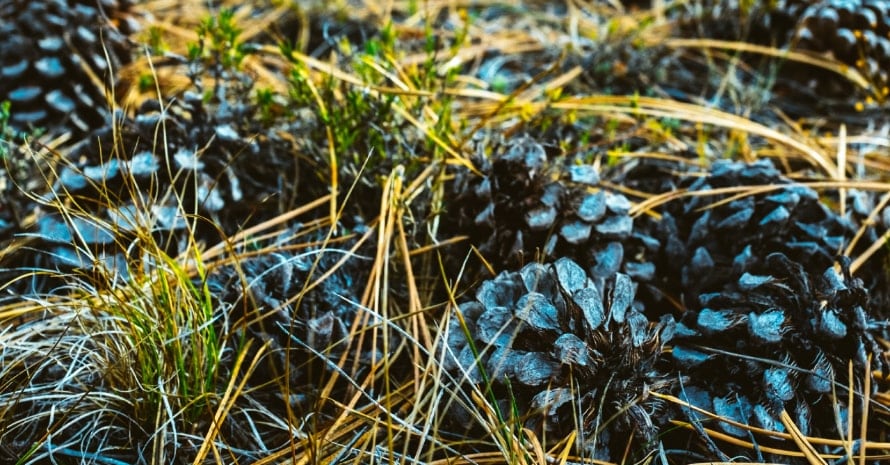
[672,253,886,463]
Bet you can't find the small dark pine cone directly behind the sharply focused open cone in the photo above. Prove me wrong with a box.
[444,137,633,278]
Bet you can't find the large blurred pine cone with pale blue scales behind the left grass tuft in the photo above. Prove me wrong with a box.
[6,65,300,292]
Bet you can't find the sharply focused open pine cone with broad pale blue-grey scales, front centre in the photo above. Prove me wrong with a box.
[446,258,673,461]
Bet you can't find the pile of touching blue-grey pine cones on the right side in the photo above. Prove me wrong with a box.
[446,138,888,461]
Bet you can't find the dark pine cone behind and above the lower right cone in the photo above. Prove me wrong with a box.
[637,160,886,309]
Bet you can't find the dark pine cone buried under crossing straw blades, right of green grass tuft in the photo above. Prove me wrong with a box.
[207,228,386,408]
